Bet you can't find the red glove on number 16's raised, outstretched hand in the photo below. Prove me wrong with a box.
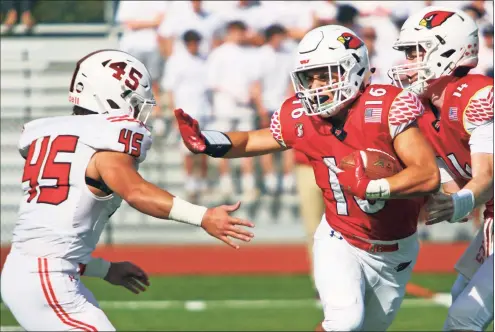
[174,108,206,153]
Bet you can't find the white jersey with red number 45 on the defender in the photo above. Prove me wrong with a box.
[12,113,152,264]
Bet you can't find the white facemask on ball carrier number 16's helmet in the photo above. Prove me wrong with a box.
[291,56,359,117]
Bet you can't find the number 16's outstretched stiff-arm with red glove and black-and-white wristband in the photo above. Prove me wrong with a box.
[174,109,287,158]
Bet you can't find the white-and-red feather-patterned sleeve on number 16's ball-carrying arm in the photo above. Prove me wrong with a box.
[388,90,424,139]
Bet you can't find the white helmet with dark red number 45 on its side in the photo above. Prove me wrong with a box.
[69,50,156,123]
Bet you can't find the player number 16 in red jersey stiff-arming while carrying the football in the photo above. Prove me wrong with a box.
[175,25,440,331]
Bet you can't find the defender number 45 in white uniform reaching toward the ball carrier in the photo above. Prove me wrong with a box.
[1,50,254,331]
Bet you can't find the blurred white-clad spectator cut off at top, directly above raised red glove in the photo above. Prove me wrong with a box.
[158,1,219,58]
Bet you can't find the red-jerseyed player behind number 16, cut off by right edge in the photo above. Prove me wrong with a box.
[390,7,493,331]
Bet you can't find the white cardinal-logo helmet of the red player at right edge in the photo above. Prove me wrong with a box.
[389,6,479,95]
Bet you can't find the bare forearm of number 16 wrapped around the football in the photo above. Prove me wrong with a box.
[386,165,440,198]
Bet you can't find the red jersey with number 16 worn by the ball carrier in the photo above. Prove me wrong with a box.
[270,85,424,241]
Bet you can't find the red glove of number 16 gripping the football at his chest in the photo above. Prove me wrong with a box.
[326,153,371,199]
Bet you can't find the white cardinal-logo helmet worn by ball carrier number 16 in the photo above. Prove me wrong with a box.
[291,25,369,117]
